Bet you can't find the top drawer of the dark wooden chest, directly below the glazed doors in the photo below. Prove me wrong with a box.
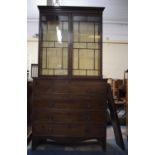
[33,79,107,94]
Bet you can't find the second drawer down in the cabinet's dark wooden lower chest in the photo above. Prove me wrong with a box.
[33,95,107,109]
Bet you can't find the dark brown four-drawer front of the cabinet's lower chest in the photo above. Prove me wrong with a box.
[33,79,107,148]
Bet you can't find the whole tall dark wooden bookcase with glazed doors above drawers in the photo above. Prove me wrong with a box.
[32,6,107,148]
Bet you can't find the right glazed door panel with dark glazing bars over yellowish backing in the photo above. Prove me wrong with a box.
[73,16,101,76]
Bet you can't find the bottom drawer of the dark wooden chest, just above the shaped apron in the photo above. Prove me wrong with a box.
[33,123,105,138]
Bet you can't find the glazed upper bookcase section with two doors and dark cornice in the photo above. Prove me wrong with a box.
[38,6,104,79]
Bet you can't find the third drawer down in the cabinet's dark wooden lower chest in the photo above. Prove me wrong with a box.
[33,110,106,124]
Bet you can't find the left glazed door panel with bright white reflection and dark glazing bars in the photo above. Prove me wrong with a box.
[41,16,68,75]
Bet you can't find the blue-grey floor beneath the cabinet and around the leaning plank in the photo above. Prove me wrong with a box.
[27,126,128,155]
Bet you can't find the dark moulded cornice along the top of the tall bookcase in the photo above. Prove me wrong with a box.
[38,6,105,13]
